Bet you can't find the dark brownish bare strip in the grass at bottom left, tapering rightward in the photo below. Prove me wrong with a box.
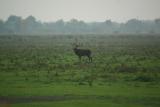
[0,95,111,104]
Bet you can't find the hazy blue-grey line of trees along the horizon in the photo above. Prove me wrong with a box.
[0,15,160,34]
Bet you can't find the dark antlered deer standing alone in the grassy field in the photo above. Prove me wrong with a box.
[73,45,92,62]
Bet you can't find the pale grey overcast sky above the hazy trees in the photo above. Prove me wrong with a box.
[0,0,160,22]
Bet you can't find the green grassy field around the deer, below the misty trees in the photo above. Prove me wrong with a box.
[0,35,160,107]
